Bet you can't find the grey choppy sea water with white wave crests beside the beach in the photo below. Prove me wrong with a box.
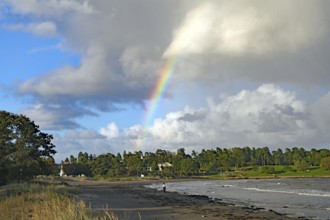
[148,178,330,219]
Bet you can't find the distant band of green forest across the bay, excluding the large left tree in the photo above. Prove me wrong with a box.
[62,147,330,177]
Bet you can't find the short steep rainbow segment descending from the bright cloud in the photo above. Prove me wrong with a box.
[144,56,178,127]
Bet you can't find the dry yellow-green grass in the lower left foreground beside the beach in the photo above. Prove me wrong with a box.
[0,182,118,220]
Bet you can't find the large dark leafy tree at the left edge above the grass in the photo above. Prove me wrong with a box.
[0,111,56,183]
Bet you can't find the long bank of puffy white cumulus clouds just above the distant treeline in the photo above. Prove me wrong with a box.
[50,84,330,162]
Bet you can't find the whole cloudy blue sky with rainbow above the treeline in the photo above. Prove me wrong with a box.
[0,0,330,162]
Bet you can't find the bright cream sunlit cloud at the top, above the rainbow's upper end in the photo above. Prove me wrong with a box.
[164,1,327,56]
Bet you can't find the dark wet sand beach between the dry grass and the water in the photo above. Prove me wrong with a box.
[69,180,302,220]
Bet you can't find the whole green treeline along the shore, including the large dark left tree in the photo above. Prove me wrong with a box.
[0,111,330,185]
